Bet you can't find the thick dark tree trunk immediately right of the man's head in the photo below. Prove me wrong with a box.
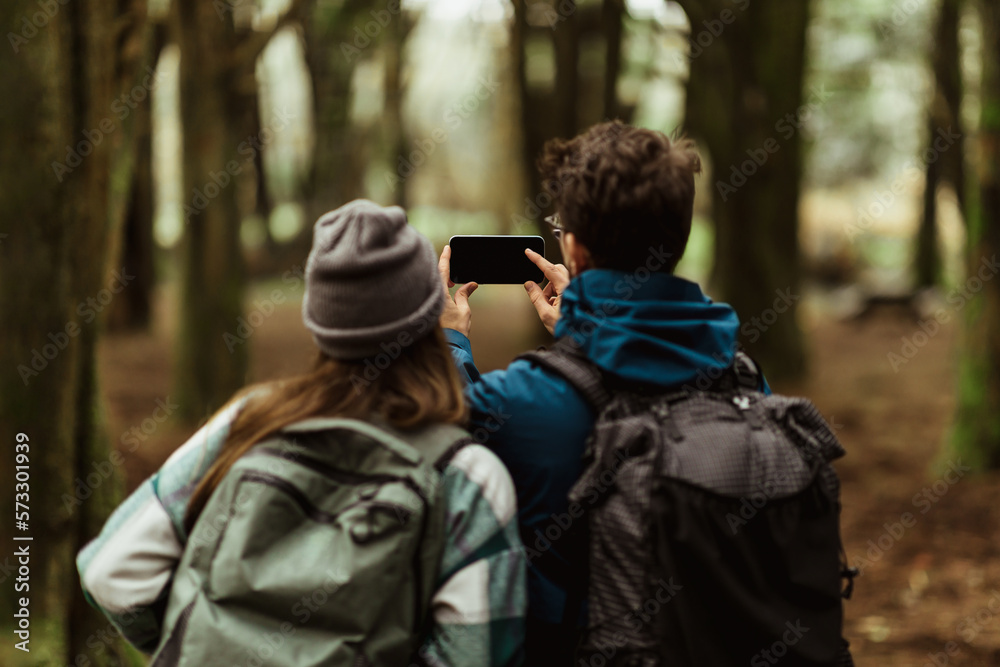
[681,0,808,379]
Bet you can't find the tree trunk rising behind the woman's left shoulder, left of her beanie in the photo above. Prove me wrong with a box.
[172,0,302,422]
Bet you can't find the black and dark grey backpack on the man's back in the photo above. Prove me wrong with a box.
[521,339,856,667]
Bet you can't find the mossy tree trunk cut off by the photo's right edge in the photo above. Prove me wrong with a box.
[949,0,1000,470]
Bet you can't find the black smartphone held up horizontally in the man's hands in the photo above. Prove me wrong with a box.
[448,235,545,285]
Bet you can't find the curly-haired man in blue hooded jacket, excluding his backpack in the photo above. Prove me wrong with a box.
[439,121,766,667]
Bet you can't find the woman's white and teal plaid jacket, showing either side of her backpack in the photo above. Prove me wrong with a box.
[77,401,527,667]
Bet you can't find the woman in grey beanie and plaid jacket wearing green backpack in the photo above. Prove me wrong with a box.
[77,200,526,667]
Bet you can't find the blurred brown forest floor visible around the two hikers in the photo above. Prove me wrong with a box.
[100,287,1000,667]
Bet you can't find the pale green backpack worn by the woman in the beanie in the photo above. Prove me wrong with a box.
[151,419,472,667]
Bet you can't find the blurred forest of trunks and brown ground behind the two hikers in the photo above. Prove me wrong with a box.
[0,0,1000,665]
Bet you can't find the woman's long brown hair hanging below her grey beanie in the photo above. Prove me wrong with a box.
[184,324,467,533]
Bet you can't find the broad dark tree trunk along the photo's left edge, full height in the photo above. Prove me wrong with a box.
[0,0,148,665]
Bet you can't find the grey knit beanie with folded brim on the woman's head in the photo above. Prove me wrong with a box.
[302,199,445,359]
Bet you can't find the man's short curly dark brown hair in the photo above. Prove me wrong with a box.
[538,120,701,272]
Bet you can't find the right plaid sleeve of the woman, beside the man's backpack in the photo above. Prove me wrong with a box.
[418,445,527,667]
